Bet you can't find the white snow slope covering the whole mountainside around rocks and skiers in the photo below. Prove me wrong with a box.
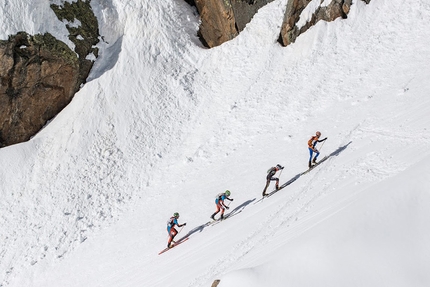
[0,0,430,287]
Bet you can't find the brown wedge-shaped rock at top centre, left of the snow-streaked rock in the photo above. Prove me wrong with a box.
[193,0,273,48]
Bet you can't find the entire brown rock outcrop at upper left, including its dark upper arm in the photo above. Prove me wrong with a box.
[0,0,99,147]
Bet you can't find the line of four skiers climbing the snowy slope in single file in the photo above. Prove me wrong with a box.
[167,131,327,248]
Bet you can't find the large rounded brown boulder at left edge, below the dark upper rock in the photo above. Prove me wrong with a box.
[0,32,80,146]
